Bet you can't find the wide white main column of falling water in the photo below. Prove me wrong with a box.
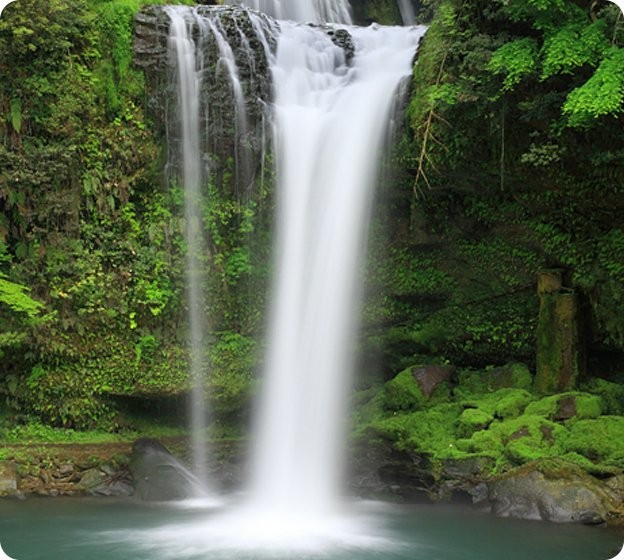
[252,22,423,516]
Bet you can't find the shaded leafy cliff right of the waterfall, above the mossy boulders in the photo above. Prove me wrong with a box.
[366,0,624,375]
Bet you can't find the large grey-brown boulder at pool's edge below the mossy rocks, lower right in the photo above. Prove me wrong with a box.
[488,460,617,524]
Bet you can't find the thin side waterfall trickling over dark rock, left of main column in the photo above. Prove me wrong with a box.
[164,6,275,488]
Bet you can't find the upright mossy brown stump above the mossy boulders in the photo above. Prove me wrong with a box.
[535,270,584,394]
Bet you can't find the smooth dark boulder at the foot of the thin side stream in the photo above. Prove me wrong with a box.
[130,438,201,501]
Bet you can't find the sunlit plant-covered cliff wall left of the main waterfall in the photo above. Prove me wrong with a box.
[0,0,266,431]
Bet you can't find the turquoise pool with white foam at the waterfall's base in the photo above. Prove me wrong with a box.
[0,498,623,560]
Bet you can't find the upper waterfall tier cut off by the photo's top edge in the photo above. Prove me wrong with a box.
[225,0,351,23]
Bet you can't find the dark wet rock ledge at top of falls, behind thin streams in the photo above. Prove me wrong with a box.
[133,6,355,192]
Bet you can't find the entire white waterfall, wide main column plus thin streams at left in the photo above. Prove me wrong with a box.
[161,0,424,546]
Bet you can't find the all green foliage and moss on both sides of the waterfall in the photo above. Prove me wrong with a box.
[0,0,624,494]
